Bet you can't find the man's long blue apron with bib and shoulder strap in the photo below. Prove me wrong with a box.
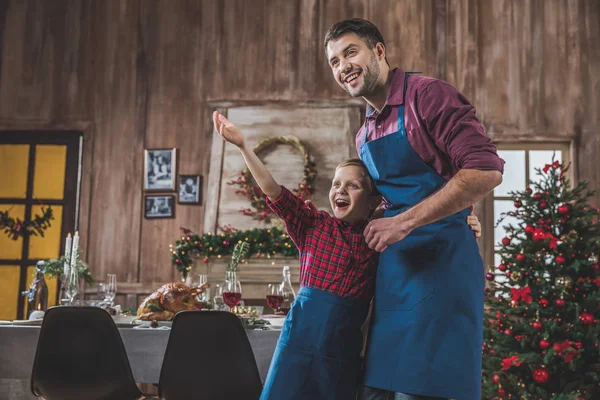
[360,74,485,400]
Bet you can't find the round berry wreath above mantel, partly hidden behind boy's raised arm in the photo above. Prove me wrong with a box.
[227,136,317,221]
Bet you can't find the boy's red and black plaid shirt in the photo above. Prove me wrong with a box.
[267,186,378,300]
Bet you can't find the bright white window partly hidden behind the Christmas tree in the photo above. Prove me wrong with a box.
[483,142,573,282]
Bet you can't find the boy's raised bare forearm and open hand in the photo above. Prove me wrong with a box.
[213,111,281,201]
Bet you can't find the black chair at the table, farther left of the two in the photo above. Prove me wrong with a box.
[31,307,156,400]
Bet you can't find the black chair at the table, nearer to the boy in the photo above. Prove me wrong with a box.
[159,311,262,400]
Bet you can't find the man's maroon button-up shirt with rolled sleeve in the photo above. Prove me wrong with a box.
[356,68,504,181]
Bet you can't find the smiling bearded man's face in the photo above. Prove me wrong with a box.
[327,33,381,97]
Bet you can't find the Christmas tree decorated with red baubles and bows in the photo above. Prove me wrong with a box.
[482,161,600,400]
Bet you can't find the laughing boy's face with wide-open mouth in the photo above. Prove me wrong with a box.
[329,165,376,223]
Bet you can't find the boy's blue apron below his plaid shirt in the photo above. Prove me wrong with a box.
[260,287,369,400]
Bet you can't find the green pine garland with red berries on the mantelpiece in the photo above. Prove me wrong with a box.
[170,228,298,278]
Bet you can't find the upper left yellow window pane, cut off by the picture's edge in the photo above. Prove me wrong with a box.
[0,144,29,199]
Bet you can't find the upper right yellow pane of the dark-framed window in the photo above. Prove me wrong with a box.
[33,144,67,200]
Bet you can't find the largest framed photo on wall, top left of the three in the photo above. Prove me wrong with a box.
[144,148,177,191]
